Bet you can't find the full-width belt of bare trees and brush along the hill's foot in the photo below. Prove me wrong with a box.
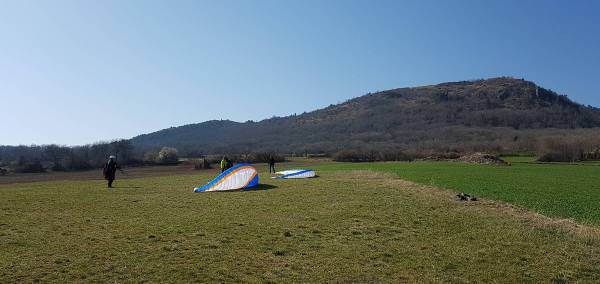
[0,128,600,174]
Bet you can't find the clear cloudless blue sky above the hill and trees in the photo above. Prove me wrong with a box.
[0,0,600,145]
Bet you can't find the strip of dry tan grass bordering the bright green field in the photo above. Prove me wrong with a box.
[332,170,600,240]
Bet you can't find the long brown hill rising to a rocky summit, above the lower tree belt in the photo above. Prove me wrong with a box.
[131,77,600,154]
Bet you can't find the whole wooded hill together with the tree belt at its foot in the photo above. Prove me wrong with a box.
[0,77,600,172]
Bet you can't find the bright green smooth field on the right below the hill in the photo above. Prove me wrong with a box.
[316,157,600,225]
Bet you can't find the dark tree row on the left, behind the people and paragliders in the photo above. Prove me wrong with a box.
[0,140,285,175]
